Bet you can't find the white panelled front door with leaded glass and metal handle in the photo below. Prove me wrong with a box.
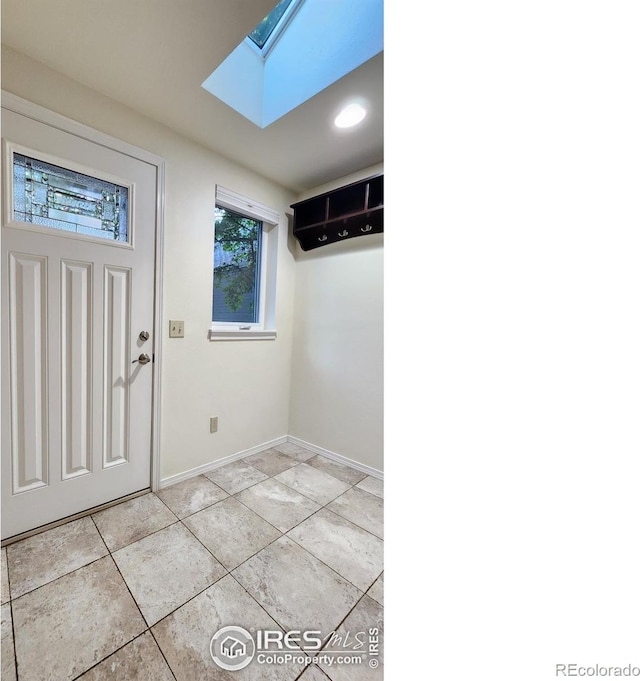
[1,101,158,539]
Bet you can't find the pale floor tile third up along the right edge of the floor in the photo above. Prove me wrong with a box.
[287,508,384,592]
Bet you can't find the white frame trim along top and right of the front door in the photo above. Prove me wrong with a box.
[0,90,166,492]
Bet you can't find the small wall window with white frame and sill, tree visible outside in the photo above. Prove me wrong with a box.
[209,187,279,340]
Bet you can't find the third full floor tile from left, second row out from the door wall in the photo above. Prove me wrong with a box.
[183,497,280,570]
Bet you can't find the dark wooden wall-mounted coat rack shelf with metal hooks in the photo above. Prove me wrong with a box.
[291,175,384,251]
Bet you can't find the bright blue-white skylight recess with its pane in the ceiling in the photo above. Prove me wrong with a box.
[202,0,384,128]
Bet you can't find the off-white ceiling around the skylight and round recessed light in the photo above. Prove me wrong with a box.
[1,0,383,192]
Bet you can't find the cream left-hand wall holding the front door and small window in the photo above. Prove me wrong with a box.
[2,47,295,478]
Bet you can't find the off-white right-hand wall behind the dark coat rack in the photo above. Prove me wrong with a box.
[289,166,383,470]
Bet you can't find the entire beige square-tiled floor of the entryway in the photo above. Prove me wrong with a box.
[1,443,383,681]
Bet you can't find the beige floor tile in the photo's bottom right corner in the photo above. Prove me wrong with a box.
[319,596,384,681]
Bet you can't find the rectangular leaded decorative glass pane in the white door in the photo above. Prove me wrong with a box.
[13,153,129,243]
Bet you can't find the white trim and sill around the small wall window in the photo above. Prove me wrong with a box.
[209,185,280,341]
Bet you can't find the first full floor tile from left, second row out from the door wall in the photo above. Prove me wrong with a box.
[12,556,146,681]
